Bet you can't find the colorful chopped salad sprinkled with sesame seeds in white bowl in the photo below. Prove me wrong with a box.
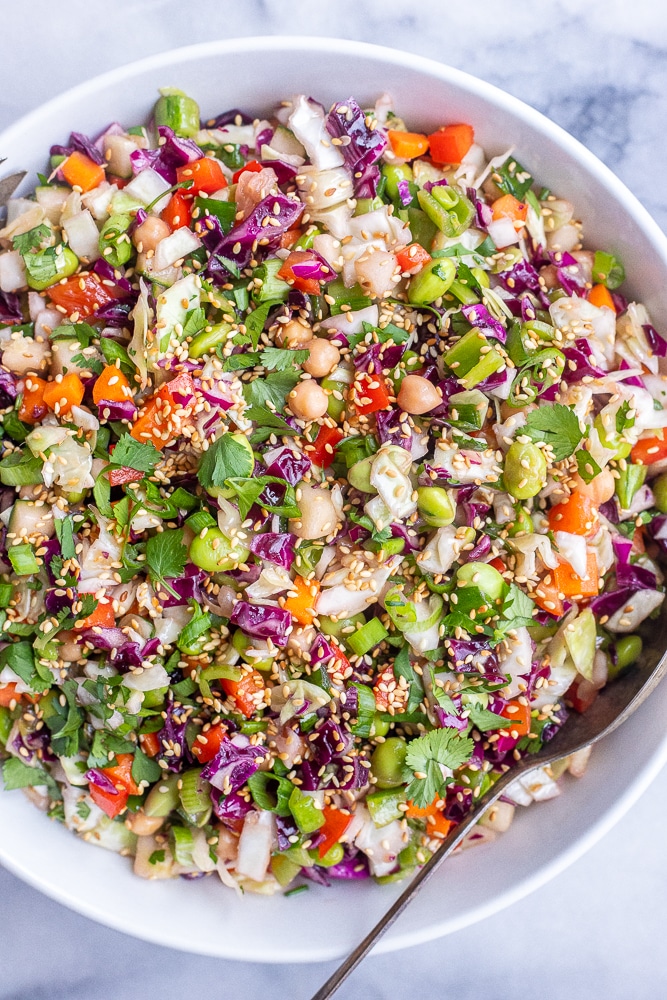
[0,89,667,893]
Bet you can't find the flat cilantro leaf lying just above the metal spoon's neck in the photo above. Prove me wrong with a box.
[405,728,475,809]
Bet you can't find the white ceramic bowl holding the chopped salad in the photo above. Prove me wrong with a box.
[0,38,667,962]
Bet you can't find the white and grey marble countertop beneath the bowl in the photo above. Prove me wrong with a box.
[0,0,667,1000]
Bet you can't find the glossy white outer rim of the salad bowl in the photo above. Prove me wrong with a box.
[0,35,667,963]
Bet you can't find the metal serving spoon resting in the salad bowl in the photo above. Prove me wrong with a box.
[311,640,667,1000]
